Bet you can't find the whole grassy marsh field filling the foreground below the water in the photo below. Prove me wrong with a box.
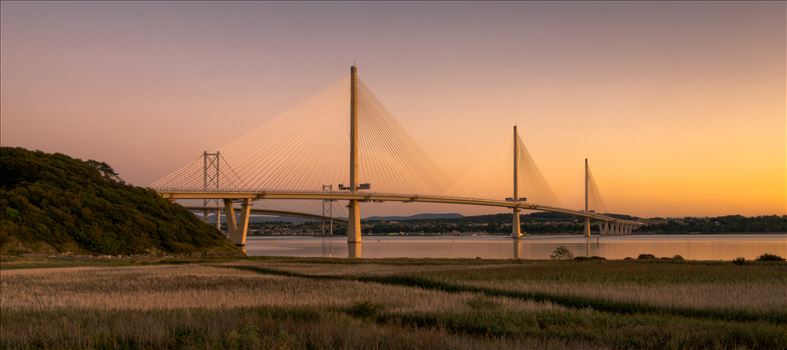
[0,257,787,349]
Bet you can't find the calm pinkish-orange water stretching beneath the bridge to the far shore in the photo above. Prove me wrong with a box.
[246,233,787,260]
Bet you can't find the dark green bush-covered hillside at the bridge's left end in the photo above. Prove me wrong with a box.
[0,147,239,255]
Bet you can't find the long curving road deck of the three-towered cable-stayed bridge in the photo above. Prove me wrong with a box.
[156,189,644,226]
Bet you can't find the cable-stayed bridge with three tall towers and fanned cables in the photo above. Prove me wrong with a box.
[151,66,643,256]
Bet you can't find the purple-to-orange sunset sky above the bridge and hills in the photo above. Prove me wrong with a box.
[0,1,787,216]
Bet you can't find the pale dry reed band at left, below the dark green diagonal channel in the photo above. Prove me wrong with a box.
[0,265,559,312]
